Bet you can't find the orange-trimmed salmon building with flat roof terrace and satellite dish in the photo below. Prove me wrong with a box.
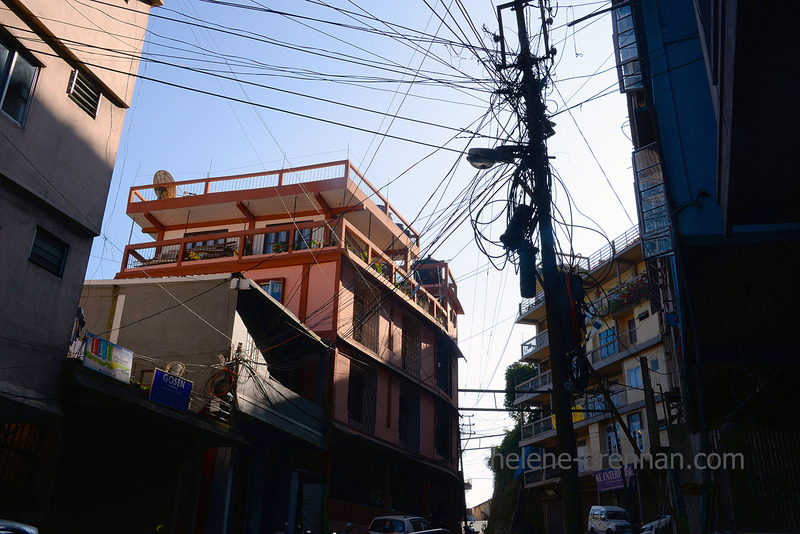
[112,161,464,531]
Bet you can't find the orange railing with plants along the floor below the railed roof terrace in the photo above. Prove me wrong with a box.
[120,220,456,337]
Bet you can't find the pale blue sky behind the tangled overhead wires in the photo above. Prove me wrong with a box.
[80,0,636,506]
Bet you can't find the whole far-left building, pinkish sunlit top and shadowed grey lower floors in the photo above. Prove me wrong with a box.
[0,0,161,528]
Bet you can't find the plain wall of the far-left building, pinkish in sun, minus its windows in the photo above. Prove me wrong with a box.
[0,0,150,406]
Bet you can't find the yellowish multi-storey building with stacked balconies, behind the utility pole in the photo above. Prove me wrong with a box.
[515,227,679,534]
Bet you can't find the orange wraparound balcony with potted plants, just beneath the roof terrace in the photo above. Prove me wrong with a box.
[117,220,457,337]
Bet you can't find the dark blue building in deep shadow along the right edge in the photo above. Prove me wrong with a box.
[613,0,800,532]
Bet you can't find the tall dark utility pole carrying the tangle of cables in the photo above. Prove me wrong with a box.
[510,0,583,534]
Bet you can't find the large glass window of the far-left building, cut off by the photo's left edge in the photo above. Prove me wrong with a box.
[0,43,37,126]
